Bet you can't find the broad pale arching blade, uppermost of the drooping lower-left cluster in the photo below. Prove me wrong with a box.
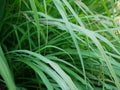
[11,50,78,90]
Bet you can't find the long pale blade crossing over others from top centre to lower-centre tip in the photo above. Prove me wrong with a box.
[53,0,86,84]
